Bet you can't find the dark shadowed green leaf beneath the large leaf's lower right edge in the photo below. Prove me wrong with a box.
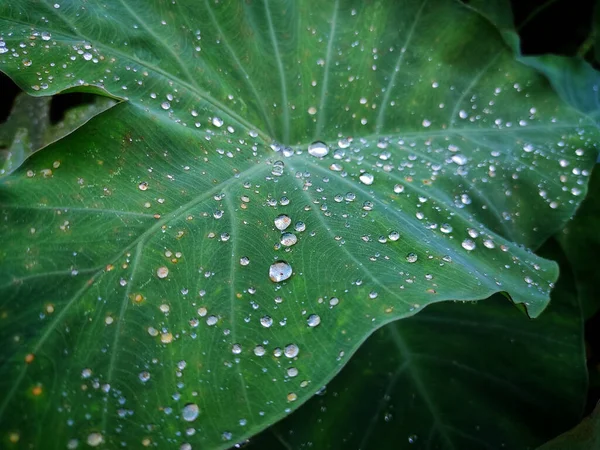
[246,243,584,450]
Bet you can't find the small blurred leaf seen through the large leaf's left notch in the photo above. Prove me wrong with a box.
[0,94,115,176]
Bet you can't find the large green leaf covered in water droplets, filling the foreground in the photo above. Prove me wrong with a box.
[0,0,598,448]
